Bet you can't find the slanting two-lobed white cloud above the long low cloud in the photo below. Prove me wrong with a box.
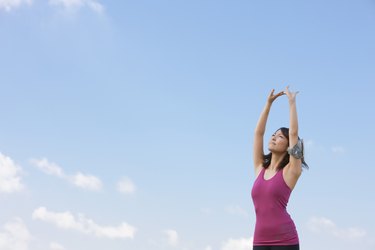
[30,158,103,191]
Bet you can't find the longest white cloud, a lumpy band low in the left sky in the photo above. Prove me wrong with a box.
[33,207,136,239]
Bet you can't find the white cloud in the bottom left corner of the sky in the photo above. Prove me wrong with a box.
[0,218,32,250]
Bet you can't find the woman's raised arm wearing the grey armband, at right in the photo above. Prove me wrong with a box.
[285,87,302,180]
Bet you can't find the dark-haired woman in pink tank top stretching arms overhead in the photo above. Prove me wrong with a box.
[251,87,307,250]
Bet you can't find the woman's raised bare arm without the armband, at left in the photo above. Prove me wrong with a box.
[253,89,284,174]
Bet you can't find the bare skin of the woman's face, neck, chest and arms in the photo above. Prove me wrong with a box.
[253,87,302,190]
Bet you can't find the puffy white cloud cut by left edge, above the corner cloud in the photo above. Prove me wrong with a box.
[0,153,23,193]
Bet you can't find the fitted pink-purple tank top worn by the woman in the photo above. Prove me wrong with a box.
[251,168,299,246]
